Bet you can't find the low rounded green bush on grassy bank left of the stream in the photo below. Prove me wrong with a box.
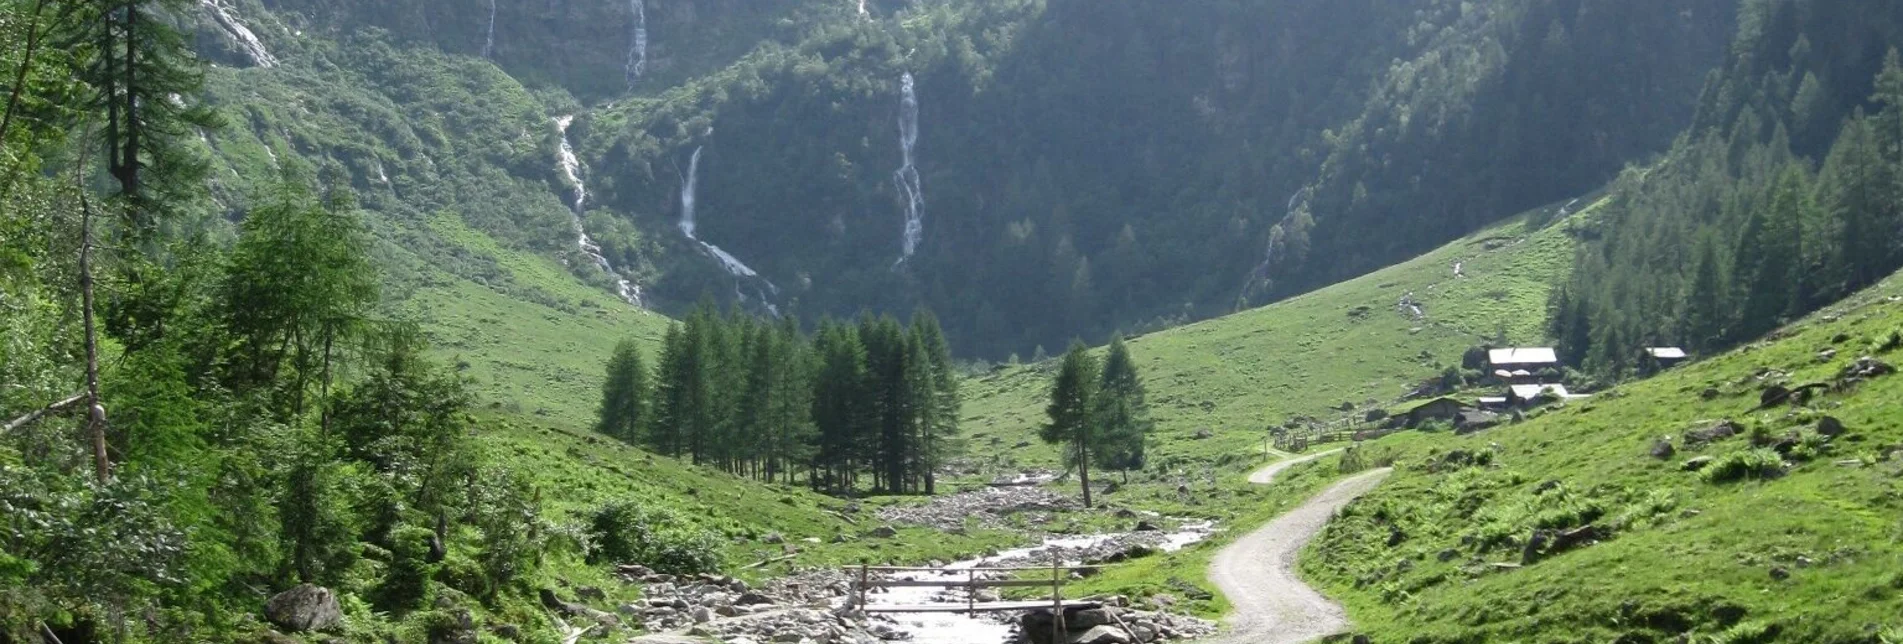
[588,501,721,575]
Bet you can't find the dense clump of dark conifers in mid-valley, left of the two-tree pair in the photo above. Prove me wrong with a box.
[598,301,959,493]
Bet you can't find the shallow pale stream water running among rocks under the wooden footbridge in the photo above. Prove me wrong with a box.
[866,522,1214,644]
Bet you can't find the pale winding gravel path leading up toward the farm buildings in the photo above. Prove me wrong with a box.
[1207,450,1391,644]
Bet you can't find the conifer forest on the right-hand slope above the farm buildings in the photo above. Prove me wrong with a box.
[1551,2,1903,377]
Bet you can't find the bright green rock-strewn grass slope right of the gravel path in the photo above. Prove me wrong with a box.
[1304,278,1903,642]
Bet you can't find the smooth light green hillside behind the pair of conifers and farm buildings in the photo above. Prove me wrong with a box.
[963,204,1597,476]
